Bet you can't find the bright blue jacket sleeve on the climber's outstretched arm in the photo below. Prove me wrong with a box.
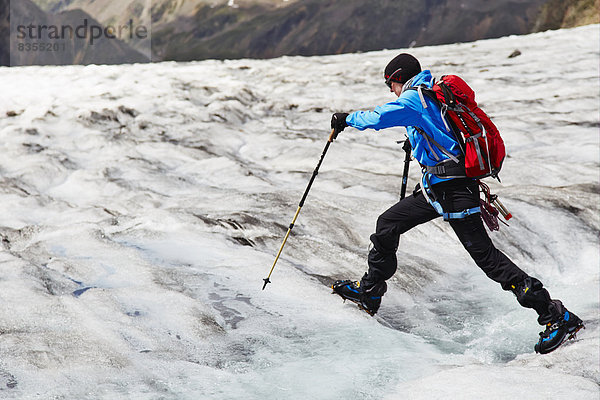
[346,93,420,131]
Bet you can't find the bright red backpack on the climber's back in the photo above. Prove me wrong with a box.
[416,75,506,178]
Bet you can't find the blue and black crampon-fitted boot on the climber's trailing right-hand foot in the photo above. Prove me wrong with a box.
[534,300,585,354]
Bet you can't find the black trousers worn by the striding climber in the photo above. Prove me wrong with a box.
[362,179,549,315]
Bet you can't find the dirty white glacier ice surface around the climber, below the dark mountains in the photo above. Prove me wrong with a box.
[0,26,600,400]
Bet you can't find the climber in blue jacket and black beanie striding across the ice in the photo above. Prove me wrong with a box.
[331,53,583,353]
